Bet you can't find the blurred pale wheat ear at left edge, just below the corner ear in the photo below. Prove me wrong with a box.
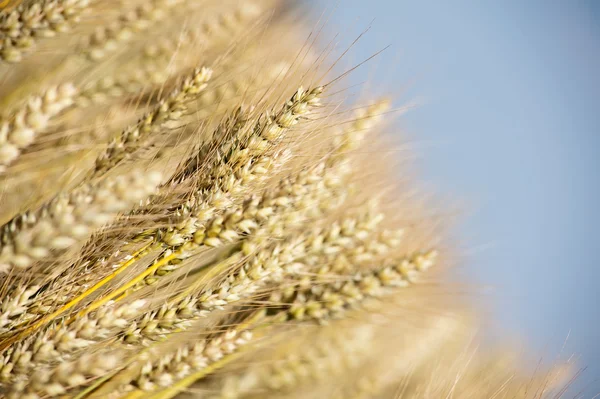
[0,83,77,173]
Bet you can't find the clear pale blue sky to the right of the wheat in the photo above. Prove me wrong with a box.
[309,0,600,398]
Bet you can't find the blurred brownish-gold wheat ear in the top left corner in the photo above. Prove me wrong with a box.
[0,0,92,63]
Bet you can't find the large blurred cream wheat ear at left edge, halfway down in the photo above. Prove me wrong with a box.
[0,170,161,272]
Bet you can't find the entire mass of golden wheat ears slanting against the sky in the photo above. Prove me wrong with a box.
[0,0,576,399]
